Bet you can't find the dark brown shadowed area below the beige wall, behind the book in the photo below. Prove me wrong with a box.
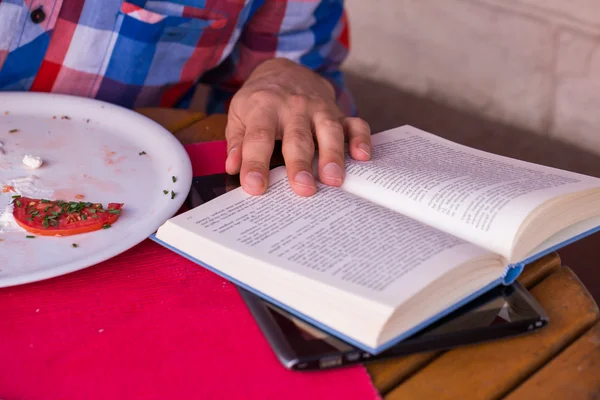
[346,72,600,301]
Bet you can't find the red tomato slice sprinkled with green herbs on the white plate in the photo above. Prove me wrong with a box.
[13,196,123,236]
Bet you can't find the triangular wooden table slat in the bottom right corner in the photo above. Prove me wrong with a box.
[507,323,600,400]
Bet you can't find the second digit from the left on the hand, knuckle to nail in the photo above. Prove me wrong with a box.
[240,110,279,195]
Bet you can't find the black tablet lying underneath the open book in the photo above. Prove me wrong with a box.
[188,170,548,370]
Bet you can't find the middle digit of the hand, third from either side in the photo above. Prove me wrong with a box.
[281,112,317,196]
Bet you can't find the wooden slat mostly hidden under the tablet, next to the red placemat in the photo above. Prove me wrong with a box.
[367,253,560,394]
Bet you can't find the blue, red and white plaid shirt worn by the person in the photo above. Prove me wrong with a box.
[0,0,354,114]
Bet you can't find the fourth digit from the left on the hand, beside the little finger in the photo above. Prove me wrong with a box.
[313,112,344,186]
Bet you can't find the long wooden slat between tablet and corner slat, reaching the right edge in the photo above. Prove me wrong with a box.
[386,267,599,400]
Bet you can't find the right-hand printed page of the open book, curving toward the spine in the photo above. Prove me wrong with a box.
[343,126,600,259]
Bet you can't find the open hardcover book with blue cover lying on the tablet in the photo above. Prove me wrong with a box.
[153,126,600,354]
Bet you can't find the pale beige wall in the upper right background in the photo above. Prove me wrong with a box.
[345,0,600,154]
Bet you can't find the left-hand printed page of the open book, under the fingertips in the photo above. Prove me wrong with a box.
[173,168,496,306]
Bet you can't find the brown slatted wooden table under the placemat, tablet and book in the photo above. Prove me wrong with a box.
[138,109,600,400]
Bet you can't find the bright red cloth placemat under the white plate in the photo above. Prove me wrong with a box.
[0,142,379,400]
